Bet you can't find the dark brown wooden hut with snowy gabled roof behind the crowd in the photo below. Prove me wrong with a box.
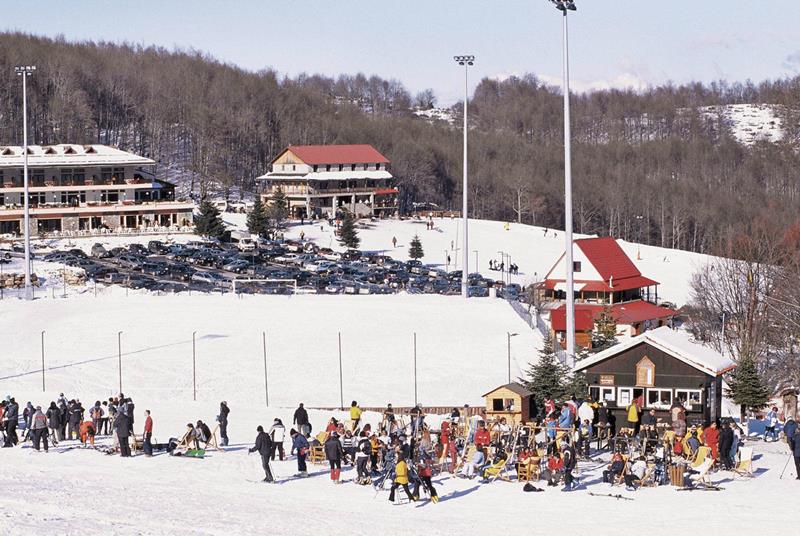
[574,327,736,424]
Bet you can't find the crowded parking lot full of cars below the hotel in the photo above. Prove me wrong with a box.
[36,240,520,300]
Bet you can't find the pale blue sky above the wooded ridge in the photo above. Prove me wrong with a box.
[0,0,800,104]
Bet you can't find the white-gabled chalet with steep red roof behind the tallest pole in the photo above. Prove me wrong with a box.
[538,237,677,348]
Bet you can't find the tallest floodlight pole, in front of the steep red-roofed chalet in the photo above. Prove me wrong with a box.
[550,0,577,359]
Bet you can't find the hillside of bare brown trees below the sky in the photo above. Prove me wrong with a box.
[0,34,800,252]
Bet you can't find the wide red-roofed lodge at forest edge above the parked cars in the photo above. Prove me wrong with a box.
[256,145,397,218]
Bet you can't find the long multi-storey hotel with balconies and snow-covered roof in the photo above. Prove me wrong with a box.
[0,144,193,235]
